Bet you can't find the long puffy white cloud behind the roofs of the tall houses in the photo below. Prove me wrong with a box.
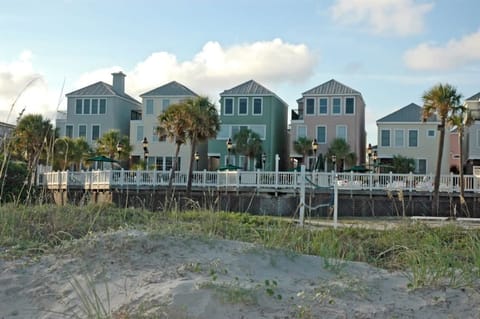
[76,39,317,100]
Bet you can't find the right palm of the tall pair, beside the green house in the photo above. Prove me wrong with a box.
[184,96,220,194]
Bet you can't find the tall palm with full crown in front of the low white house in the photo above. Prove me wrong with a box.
[422,83,462,215]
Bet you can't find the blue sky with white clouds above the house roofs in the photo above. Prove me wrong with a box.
[0,0,480,144]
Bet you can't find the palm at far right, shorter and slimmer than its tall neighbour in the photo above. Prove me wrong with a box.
[448,105,473,215]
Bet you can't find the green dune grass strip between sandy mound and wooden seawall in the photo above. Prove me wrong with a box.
[0,205,480,288]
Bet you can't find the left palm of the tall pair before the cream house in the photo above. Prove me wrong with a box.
[157,102,188,191]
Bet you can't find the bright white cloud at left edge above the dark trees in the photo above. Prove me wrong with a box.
[0,51,58,123]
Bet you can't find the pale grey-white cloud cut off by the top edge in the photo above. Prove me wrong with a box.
[331,0,433,36]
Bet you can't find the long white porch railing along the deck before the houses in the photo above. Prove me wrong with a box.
[42,170,480,193]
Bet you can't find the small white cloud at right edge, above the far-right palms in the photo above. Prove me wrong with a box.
[404,31,480,71]
